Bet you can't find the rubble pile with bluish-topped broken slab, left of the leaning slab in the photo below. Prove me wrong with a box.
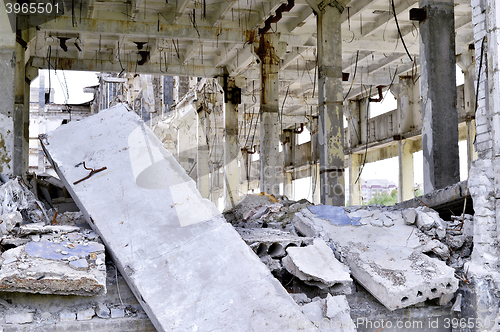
[0,178,106,296]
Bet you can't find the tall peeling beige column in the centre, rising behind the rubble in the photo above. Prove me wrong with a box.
[316,3,345,206]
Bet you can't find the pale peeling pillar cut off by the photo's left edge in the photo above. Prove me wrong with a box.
[0,7,16,175]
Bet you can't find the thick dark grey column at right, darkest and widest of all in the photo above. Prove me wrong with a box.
[419,0,460,193]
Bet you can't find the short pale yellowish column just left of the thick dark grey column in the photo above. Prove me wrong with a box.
[398,140,415,202]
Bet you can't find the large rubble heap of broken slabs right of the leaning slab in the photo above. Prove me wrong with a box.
[225,195,473,321]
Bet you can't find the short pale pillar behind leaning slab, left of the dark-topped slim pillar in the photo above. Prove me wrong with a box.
[196,108,210,198]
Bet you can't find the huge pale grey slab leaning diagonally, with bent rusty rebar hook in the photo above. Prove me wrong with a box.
[41,105,316,331]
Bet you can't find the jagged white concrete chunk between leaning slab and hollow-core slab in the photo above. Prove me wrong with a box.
[282,239,352,294]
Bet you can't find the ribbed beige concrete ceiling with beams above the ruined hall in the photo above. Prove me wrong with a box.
[17,0,473,115]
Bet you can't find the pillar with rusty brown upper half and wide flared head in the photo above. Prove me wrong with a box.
[255,33,286,196]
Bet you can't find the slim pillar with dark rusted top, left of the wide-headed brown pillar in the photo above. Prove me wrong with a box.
[224,78,241,209]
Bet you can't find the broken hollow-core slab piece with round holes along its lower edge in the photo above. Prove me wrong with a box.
[346,244,458,310]
